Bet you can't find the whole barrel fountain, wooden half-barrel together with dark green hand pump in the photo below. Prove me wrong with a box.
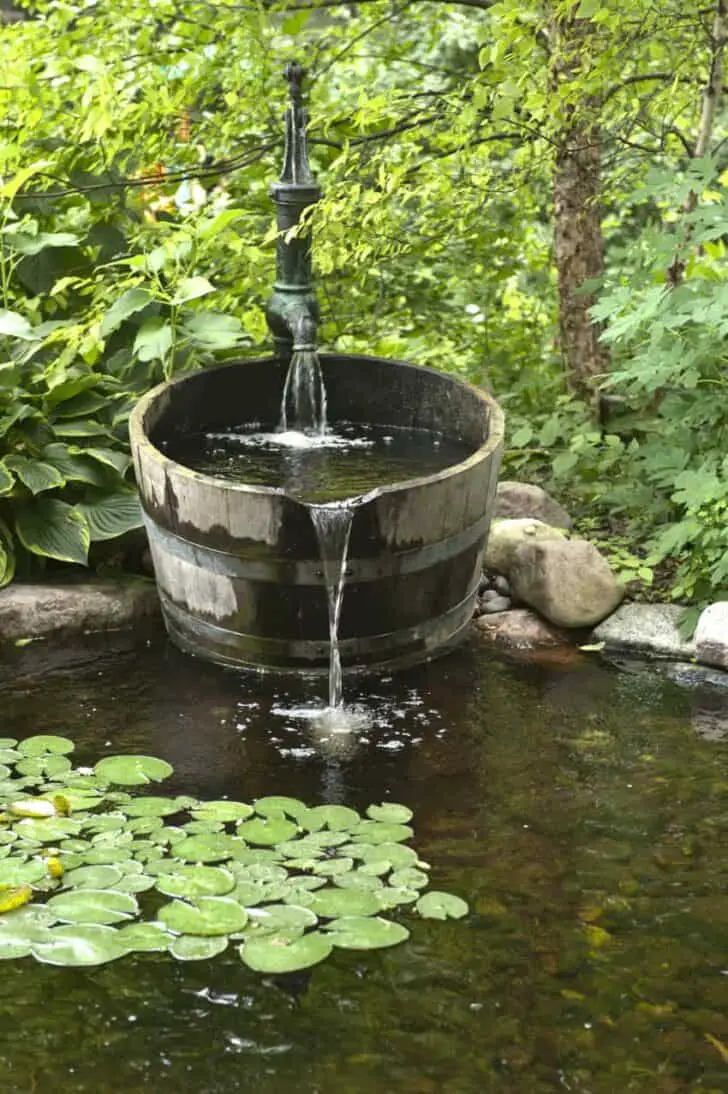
[130,65,504,691]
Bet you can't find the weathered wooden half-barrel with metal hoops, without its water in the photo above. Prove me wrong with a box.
[130,354,504,671]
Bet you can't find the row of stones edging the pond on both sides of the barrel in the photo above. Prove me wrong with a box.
[0,481,728,670]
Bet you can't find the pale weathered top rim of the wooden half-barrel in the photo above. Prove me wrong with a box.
[129,353,506,509]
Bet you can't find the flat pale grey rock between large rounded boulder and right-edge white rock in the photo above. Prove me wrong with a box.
[591,604,695,661]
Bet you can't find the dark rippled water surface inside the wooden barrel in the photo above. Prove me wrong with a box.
[163,423,473,504]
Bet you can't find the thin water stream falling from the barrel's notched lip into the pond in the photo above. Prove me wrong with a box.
[309,499,352,709]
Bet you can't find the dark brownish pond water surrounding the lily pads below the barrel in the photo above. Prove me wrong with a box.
[0,636,728,1094]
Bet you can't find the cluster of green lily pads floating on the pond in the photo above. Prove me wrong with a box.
[0,734,467,973]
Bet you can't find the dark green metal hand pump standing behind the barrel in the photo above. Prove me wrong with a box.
[266,62,321,365]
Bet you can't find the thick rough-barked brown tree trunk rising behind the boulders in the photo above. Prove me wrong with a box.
[551,16,609,400]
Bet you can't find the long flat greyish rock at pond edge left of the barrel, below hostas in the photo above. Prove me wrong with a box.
[0,578,159,642]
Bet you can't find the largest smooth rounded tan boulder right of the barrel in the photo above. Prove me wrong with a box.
[510,539,624,627]
